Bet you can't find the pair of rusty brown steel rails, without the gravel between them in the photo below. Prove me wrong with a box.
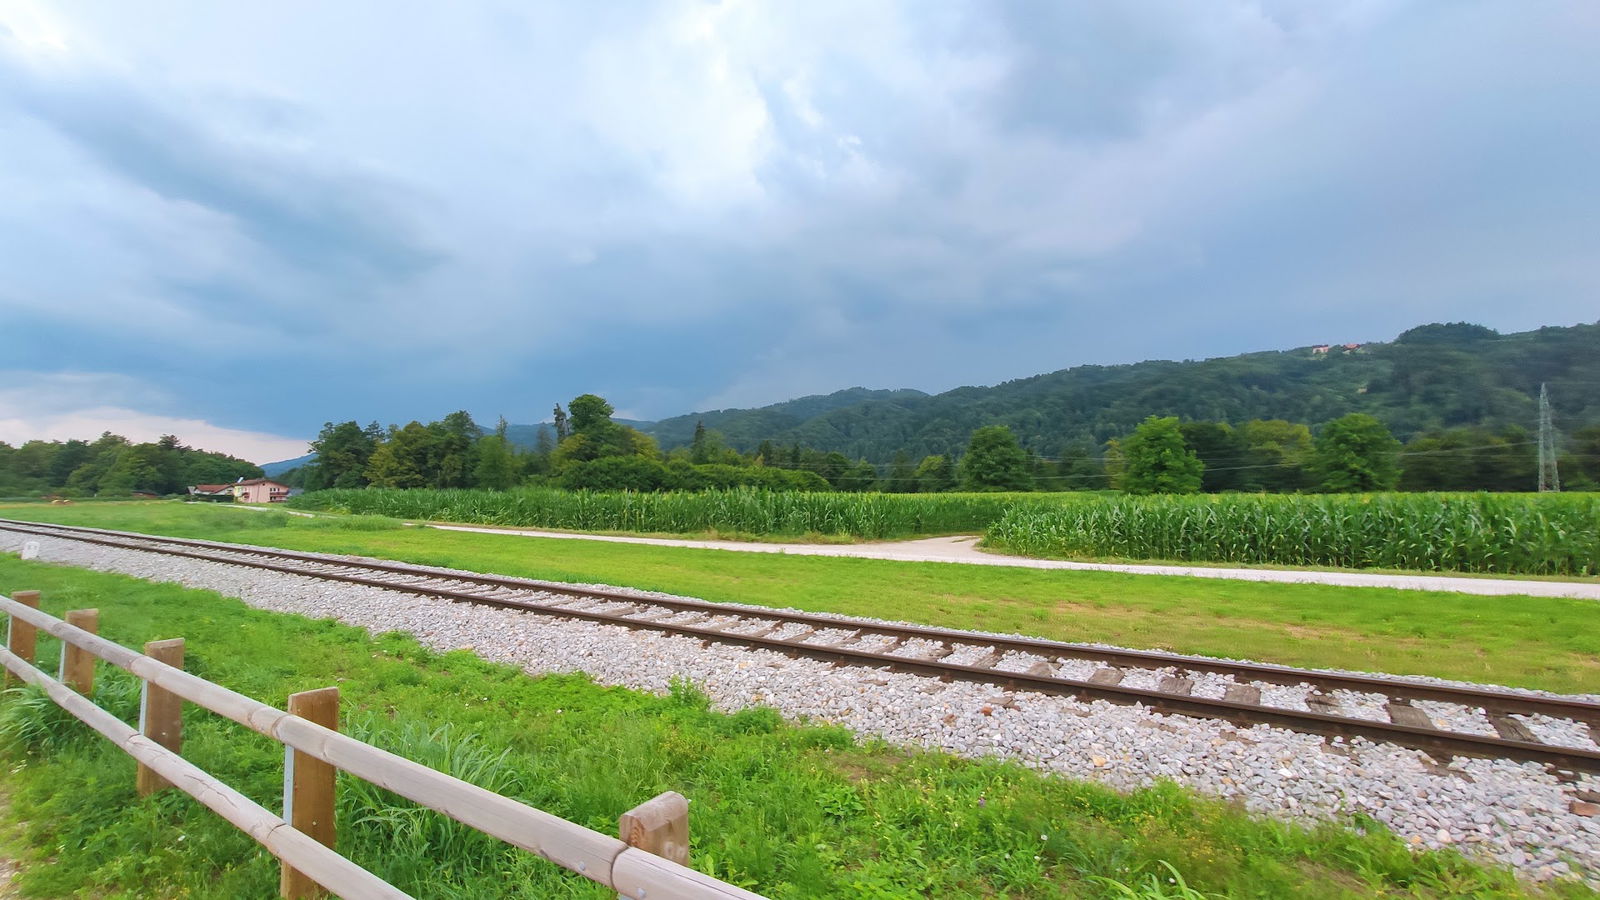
[0,519,1600,772]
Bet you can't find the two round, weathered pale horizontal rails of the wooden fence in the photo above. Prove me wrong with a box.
[0,591,762,900]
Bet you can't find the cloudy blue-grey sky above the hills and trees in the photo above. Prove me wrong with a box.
[0,0,1600,461]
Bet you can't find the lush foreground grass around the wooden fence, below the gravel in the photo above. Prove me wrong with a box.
[0,557,1594,900]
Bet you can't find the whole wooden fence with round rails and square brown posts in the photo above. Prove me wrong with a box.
[0,591,762,900]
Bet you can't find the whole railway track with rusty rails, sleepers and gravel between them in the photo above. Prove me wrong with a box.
[9,519,1600,773]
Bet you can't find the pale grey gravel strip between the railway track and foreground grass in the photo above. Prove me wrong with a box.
[0,532,1600,889]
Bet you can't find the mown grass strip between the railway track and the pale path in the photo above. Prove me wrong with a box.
[0,503,1600,692]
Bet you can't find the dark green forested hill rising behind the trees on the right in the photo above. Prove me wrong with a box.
[643,323,1600,463]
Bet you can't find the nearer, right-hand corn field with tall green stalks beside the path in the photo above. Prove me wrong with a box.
[989,493,1600,575]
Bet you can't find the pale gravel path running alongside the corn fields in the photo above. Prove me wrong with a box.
[429,525,1600,601]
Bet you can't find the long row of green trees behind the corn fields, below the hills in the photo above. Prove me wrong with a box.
[282,394,1600,493]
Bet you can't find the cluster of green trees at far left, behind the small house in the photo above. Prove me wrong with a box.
[0,431,261,496]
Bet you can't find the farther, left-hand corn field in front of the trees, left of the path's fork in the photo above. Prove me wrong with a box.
[291,488,1061,540]
